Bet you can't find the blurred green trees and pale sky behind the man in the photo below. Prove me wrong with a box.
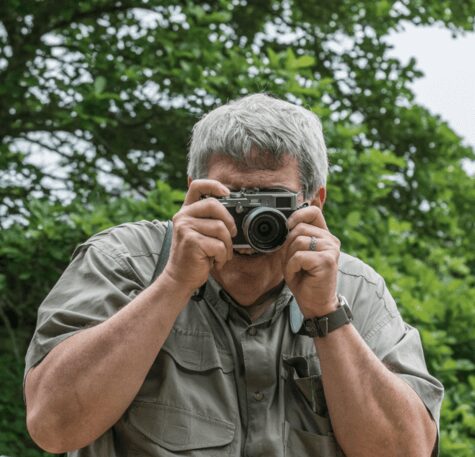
[0,0,475,457]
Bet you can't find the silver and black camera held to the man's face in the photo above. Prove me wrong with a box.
[218,189,299,253]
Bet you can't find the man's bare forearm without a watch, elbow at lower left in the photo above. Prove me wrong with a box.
[25,274,190,452]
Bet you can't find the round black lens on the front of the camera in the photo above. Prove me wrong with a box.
[242,206,289,252]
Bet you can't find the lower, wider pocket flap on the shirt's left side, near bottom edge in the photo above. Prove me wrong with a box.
[129,401,236,451]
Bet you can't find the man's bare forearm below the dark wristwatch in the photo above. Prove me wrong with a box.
[315,325,436,457]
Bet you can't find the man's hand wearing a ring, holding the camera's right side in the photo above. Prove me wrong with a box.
[283,206,340,318]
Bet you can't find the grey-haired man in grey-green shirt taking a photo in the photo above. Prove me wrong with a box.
[25,94,442,457]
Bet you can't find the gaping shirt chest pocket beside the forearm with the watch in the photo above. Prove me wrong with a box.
[283,354,343,457]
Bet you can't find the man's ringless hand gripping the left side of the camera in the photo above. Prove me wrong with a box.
[164,179,237,292]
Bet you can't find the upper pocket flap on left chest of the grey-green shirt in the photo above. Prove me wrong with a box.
[161,328,234,373]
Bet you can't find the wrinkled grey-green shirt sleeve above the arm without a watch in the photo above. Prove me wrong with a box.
[25,238,146,376]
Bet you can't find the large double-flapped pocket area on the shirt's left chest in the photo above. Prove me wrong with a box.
[121,328,239,457]
